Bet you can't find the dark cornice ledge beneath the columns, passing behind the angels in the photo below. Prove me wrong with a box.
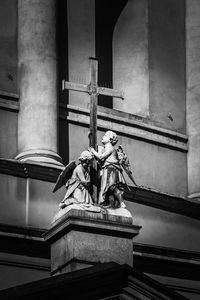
[0,158,200,220]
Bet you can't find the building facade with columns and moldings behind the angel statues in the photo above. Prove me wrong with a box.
[0,0,200,299]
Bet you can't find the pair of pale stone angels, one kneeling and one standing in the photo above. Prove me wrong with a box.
[54,131,136,209]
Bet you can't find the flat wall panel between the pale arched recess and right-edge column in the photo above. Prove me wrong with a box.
[148,0,186,133]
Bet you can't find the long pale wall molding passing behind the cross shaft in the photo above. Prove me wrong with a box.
[60,104,188,152]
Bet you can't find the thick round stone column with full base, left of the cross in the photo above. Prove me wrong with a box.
[16,0,61,164]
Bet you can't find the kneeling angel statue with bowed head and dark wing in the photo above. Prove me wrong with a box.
[53,151,93,209]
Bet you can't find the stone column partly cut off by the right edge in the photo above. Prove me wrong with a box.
[186,0,200,201]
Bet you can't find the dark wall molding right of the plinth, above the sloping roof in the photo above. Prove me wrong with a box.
[133,243,200,280]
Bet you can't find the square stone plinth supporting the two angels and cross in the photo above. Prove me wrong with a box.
[45,208,140,275]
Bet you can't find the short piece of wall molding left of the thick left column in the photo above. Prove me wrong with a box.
[0,90,19,112]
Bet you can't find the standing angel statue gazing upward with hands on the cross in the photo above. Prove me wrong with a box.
[89,131,136,208]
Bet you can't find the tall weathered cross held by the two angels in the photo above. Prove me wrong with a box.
[62,57,124,202]
